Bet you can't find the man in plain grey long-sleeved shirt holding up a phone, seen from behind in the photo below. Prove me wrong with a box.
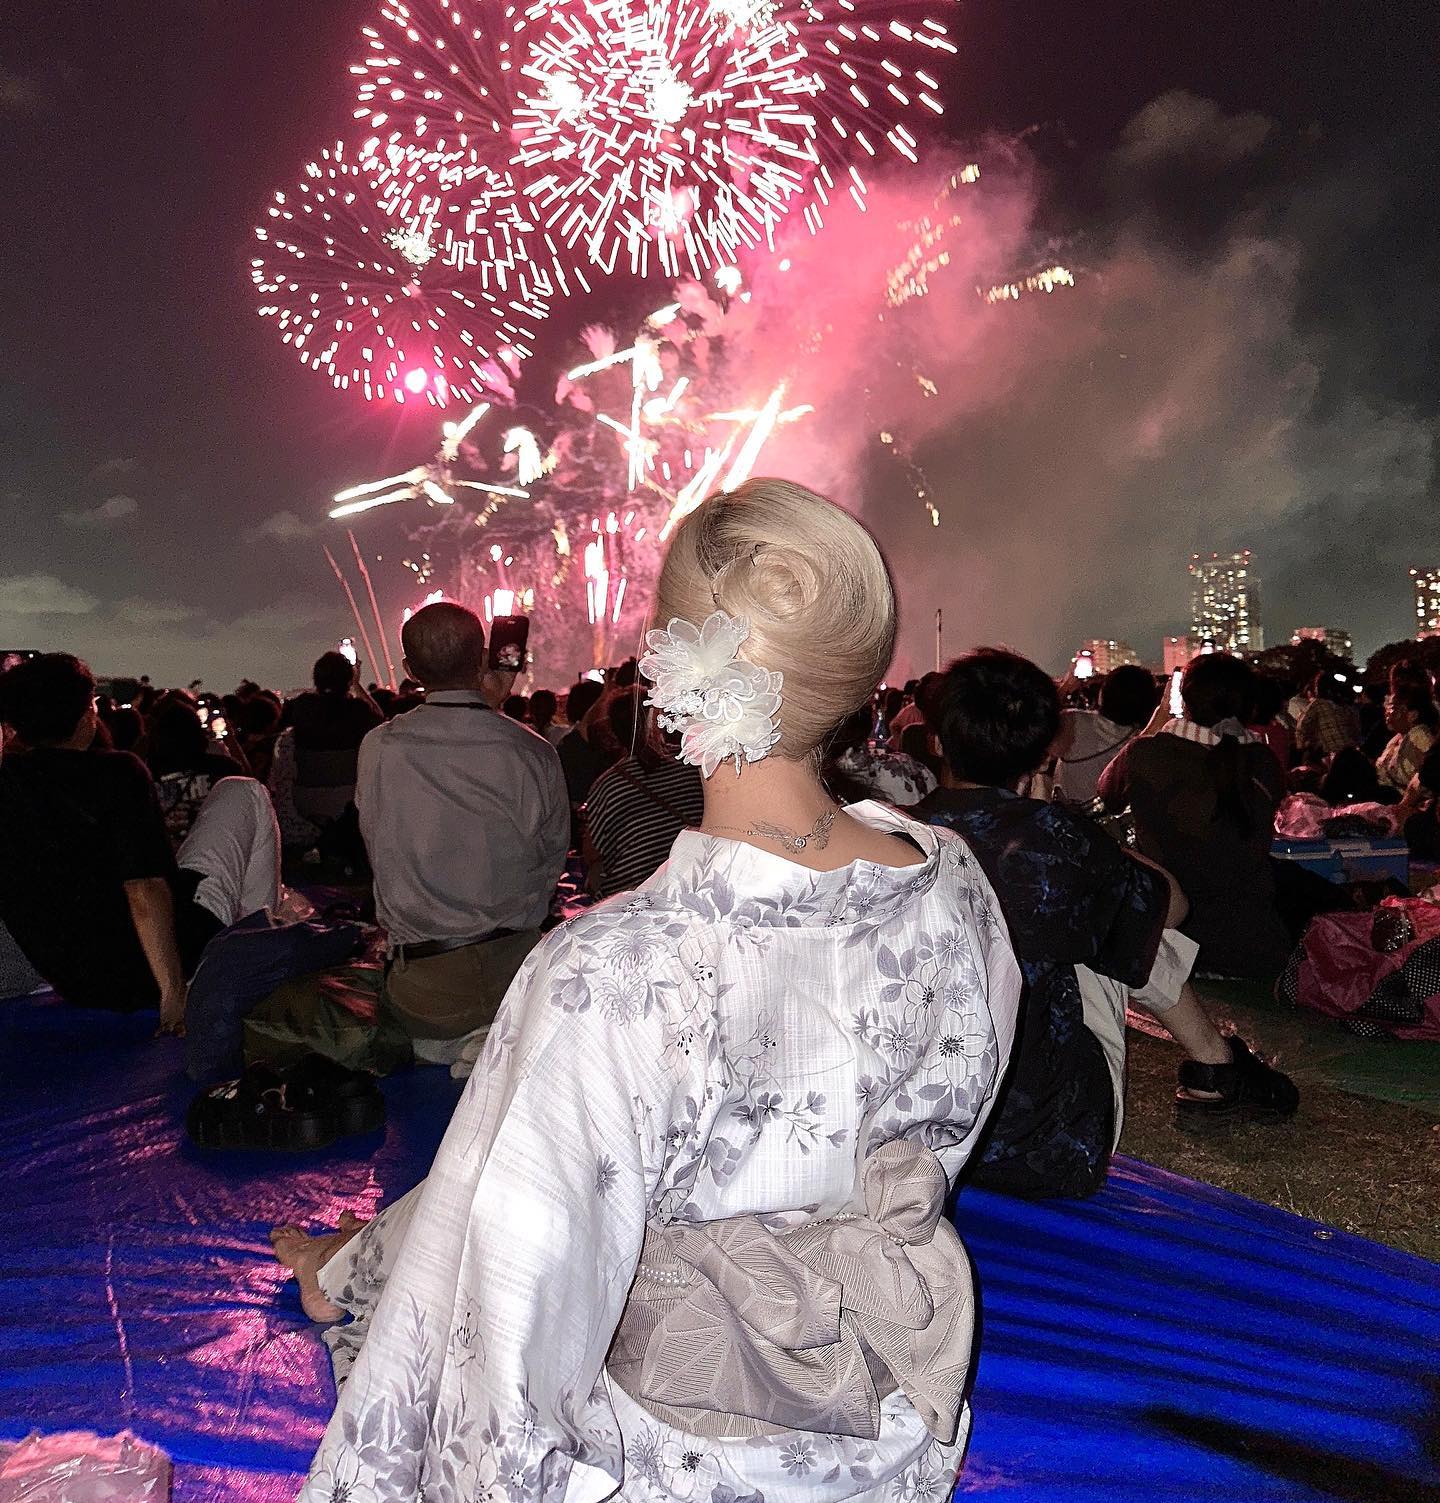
[355,601,570,1040]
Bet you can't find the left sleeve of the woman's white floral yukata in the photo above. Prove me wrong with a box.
[302,911,672,1503]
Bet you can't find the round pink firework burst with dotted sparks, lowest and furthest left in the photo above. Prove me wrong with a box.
[251,144,546,406]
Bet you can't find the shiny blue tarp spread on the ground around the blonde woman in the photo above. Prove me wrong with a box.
[0,998,1440,1503]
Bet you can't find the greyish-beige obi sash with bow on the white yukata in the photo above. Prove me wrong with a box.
[607,1139,974,1441]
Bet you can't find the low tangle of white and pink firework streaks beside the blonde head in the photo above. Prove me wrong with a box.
[331,269,812,663]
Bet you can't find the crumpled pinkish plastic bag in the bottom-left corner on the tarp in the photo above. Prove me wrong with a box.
[0,1429,170,1503]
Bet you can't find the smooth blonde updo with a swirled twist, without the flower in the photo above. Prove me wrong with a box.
[654,479,896,762]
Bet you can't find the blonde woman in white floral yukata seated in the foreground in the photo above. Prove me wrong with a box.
[277,479,1021,1503]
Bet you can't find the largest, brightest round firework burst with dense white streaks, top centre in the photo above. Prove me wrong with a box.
[514,0,830,275]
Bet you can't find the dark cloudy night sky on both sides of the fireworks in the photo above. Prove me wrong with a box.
[0,0,1440,690]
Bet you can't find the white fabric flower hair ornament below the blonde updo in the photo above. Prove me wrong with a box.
[640,610,785,777]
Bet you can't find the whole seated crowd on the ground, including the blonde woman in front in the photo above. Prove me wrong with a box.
[0,481,1440,1503]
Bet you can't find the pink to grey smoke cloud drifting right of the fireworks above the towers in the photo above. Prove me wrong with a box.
[728,93,1440,672]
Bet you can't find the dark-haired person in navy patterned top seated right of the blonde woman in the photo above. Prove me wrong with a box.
[914,648,1299,1198]
